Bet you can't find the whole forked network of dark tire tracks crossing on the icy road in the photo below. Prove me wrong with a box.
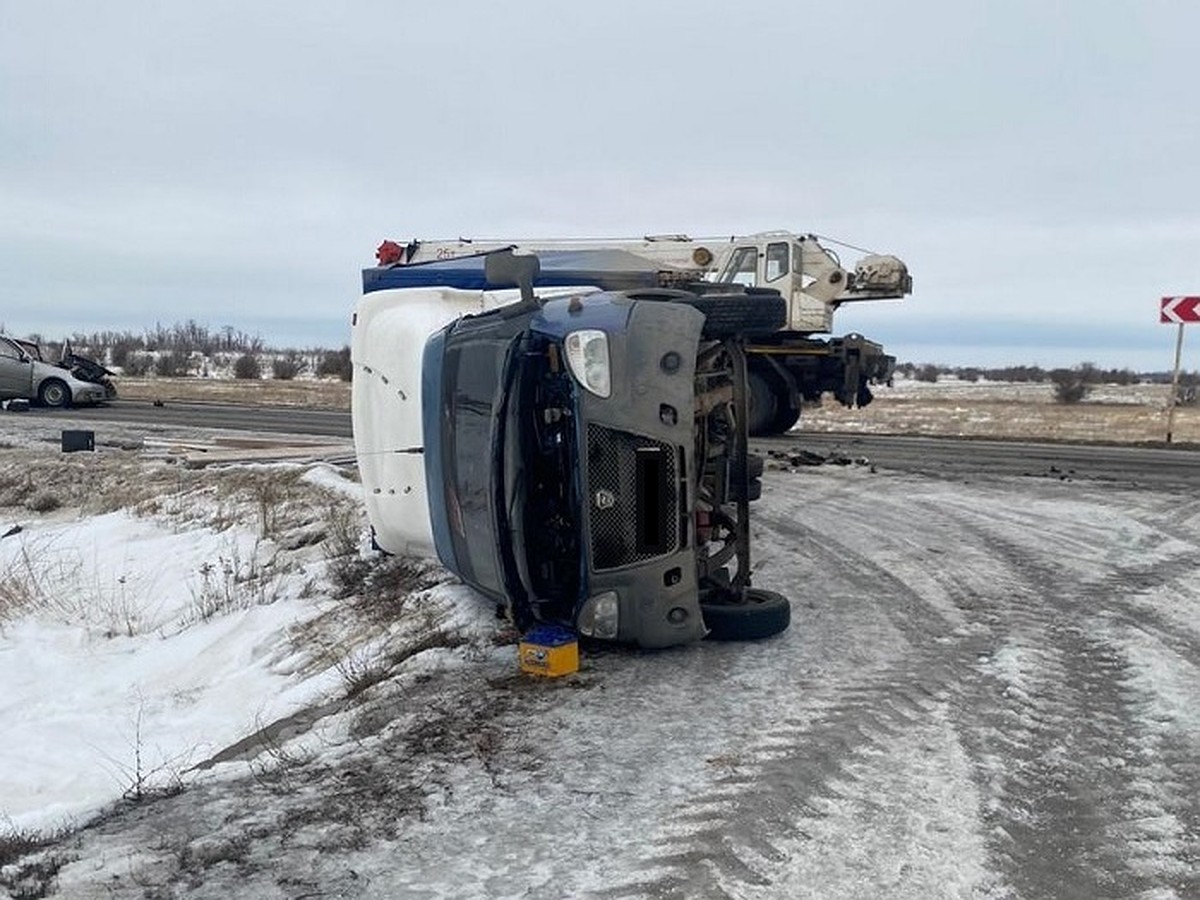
[606,475,1200,898]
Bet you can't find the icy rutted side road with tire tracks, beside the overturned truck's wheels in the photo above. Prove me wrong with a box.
[25,466,1200,899]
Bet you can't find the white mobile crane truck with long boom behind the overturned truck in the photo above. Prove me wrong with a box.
[376,232,912,436]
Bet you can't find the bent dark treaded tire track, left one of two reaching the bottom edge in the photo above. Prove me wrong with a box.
[600,487,998,898]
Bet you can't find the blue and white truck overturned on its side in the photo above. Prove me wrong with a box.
[352,251,790,647]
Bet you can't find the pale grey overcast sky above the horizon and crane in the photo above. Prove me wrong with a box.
[0,0,1200,370]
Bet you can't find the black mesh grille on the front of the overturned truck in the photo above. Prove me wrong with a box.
[587,425,679,569]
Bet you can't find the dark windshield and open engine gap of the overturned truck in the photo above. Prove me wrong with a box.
[427,307,582,618]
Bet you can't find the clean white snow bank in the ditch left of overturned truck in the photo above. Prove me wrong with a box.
[0,512,337,829]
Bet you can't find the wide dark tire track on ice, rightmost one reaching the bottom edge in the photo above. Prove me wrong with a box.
[936,496,1200,898]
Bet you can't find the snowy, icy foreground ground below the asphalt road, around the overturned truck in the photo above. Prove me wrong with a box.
[0,420,1200,899]
